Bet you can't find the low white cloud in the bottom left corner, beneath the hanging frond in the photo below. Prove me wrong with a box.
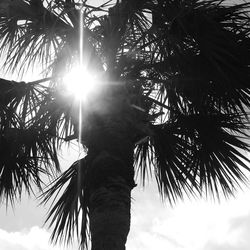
[0,226,76,250]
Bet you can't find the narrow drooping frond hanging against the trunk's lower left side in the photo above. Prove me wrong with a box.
[41,157,89,248]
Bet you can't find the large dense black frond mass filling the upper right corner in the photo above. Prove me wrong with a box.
[123,0,250,116]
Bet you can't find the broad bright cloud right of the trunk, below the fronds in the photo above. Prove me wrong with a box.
[127,182,250,250]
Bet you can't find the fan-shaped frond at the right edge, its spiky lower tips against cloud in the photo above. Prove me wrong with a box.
[179,114,250,197]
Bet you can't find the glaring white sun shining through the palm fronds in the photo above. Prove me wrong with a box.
[63,66,98,101]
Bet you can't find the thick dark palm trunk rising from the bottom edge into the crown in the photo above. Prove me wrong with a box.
[83,87,138,250]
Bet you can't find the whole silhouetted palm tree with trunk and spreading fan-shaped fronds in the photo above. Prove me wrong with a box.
[0,0,250,250]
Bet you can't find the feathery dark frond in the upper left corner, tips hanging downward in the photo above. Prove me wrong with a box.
[0,0,72,73]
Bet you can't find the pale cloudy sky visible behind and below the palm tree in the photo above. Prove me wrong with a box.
[0,0,250,250]
